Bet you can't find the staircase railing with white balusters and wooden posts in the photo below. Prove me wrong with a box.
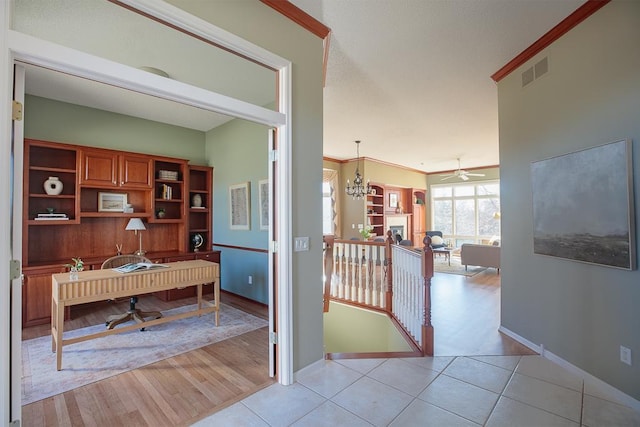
[323,232,433,356]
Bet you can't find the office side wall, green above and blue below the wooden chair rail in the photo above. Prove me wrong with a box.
[206,119,269,304]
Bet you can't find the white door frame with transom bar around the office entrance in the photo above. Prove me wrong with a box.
[0,0,293,424]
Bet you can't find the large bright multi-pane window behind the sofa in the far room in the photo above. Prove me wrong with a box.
[431,181,500,247]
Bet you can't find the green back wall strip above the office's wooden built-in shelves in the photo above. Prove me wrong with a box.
[24,95,206,165]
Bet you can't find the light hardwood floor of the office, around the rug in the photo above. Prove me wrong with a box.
[22,292,274,427]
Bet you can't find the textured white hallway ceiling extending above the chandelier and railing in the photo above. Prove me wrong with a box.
[290,0,584,172]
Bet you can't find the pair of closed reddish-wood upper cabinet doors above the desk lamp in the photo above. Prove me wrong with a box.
[80,149,153,189]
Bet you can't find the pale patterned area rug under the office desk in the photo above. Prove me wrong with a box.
[22,304,269,405]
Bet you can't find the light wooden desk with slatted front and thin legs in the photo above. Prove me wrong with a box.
[51,260,220,371]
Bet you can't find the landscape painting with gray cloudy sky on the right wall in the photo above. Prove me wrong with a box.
[531,140,636,270]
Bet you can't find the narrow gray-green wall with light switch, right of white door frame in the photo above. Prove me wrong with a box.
[170,0,323,370]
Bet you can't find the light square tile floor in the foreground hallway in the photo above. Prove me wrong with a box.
[195,356,640,427]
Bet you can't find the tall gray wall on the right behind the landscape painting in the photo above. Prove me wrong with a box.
[498,1,640,399]
